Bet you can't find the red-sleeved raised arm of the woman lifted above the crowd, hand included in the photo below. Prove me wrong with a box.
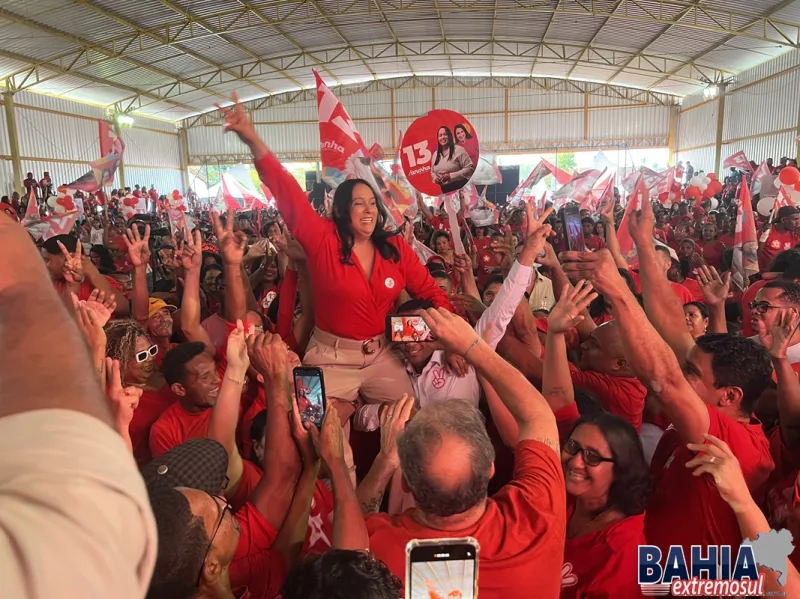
[217,92,327,252]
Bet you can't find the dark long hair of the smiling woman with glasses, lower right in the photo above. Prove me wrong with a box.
[570,412,653,516]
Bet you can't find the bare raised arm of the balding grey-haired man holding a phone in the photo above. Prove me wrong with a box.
[421,304,561,455]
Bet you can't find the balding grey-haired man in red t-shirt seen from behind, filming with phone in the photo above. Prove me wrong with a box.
[366,310,566,599]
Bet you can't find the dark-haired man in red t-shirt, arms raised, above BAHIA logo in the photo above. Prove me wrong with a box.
[565,217,774,556]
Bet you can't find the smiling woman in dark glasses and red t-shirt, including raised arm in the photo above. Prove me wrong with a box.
[542,283,653,599]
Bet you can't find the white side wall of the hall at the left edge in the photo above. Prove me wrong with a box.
[0,92,183,194]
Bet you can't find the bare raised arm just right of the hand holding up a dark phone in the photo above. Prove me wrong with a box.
[628,200,694,366]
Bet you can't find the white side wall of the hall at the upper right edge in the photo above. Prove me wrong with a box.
[677,50,800,171]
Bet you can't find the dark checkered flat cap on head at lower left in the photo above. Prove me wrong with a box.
[142,438,228,495]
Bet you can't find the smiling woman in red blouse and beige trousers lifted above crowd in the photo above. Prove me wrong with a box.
[222,97,453,422]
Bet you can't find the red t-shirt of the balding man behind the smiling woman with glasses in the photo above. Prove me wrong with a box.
[569,364,647,431]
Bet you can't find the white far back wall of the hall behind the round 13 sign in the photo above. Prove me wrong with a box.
[187,79,670,164]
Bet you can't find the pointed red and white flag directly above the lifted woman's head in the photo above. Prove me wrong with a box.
[314,70,369,177]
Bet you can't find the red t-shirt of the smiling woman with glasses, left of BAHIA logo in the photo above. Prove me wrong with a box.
[560,508,647,599]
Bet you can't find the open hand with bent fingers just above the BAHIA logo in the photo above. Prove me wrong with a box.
[686,434,753,513]
